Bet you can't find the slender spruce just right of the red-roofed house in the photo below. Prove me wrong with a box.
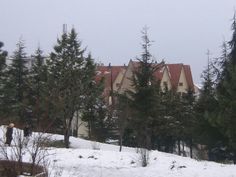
[195,54,225,158]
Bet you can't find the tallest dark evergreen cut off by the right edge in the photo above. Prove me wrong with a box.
[217,16,236,163]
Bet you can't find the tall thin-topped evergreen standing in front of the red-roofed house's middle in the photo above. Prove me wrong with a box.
[129,28,163,153]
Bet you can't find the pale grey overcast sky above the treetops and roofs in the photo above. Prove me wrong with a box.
[0,0,236,83]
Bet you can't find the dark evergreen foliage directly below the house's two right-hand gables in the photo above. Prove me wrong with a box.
[156,89,195,155]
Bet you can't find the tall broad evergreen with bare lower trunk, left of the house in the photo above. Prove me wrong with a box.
[48,29,84,148]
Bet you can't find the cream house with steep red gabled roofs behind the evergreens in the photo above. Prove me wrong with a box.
[96,60,198,105]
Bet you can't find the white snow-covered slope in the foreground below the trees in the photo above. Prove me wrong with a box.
[0,127,236,177]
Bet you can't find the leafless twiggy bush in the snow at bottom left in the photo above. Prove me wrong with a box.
[0,128,49,175]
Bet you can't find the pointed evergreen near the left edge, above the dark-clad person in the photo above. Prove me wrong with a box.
[4,40,28,123]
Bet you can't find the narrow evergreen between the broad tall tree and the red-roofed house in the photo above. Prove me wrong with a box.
[82,54,108,142]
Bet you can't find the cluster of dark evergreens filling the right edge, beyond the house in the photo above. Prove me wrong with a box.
[195,15,236,162]
